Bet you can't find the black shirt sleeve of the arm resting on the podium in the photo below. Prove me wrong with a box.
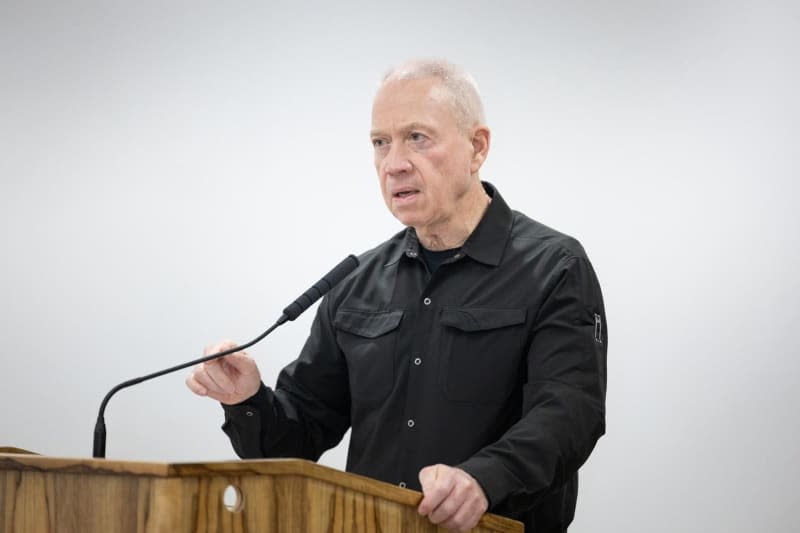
[458,257,608,513]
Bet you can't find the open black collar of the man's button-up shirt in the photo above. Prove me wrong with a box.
[385,181,514,266]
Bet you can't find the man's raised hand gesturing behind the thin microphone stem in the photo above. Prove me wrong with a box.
[186,340,261,405]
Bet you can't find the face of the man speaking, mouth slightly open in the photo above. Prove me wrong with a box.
[370,78,480,230]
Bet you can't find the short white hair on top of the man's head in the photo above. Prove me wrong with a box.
[381,59,486,130]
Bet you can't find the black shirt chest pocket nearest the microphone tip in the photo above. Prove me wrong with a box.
[333,309,403,405]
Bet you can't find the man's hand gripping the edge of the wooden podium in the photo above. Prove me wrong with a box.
[418,465,489,531]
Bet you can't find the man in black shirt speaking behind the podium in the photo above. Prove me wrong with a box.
[187,61,607,532]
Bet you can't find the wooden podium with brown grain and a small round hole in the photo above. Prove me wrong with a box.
[0,448,523,533]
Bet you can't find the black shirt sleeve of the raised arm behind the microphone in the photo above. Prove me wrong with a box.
[222,298,350,461]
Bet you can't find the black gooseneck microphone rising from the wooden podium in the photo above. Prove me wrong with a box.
[92,255,358,458]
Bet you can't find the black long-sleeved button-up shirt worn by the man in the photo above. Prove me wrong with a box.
[223,183,608,531]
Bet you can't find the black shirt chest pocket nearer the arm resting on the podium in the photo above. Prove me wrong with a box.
[439,308,525,403]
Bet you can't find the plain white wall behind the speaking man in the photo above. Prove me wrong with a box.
[0,0,800,533]
